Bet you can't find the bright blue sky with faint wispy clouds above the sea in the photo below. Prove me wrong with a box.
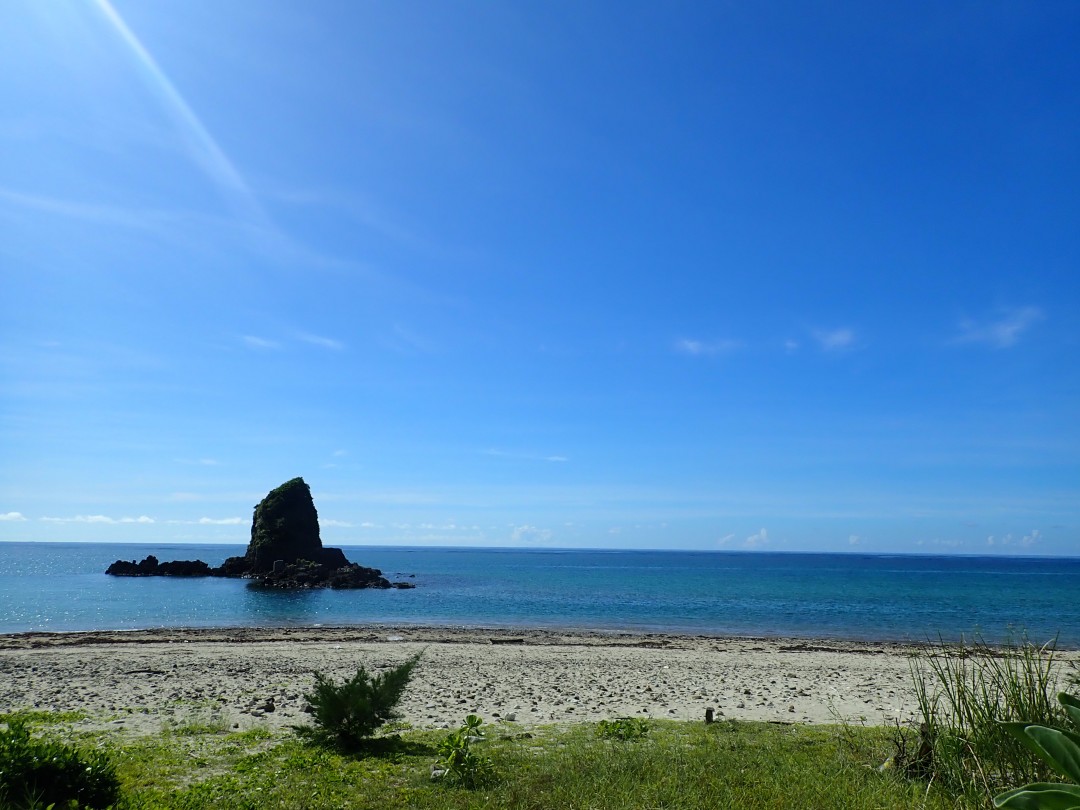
[0,0,1080,554]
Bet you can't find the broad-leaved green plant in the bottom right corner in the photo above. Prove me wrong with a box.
[994,692,1080,810]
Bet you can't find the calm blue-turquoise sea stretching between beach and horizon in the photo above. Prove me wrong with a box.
[0,542,1080,649]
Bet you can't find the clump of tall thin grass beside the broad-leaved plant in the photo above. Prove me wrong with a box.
[906,642,1065,800]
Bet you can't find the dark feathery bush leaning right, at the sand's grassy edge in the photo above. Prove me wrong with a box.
[294,652,421,751]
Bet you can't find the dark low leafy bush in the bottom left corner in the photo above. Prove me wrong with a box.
[0,715,120,808]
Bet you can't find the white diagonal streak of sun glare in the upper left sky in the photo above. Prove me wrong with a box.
[94,0,269,228]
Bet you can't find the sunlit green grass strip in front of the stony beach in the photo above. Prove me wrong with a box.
[4,721,973,810]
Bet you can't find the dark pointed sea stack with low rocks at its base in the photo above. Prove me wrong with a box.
[105,478,415,589]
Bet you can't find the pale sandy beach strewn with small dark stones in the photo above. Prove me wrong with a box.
[0,626,1080,733]
